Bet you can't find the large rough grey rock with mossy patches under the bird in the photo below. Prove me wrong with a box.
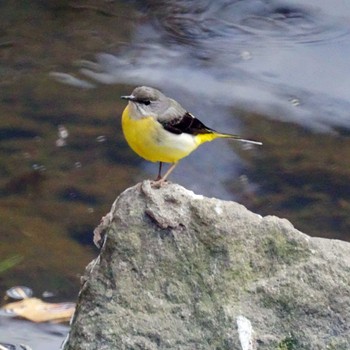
[64,181,350,350]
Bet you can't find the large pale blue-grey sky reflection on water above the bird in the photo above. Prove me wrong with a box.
[78,1,350,131]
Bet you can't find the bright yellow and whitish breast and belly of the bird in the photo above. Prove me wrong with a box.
[122,106,219,163]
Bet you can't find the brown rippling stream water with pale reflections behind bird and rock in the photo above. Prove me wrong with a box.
[0,0,350,350]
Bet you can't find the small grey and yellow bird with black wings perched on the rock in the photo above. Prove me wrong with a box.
[121,86,262,184]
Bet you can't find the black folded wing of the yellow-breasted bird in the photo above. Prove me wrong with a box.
[159,112,214,135]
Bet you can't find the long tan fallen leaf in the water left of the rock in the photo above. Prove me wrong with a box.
[2,298,75,322]
